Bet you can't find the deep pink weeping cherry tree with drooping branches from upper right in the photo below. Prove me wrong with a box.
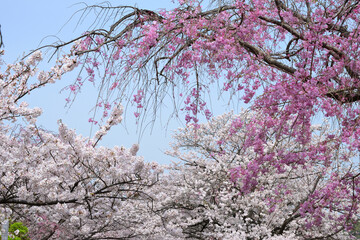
[45,0,360,234]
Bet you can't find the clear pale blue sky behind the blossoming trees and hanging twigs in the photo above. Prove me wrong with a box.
[0,0,236,163]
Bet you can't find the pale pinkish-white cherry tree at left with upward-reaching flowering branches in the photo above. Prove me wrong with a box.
[0,49,164,239]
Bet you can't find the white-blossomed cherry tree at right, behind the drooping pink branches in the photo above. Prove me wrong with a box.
[158,112,357,239]
